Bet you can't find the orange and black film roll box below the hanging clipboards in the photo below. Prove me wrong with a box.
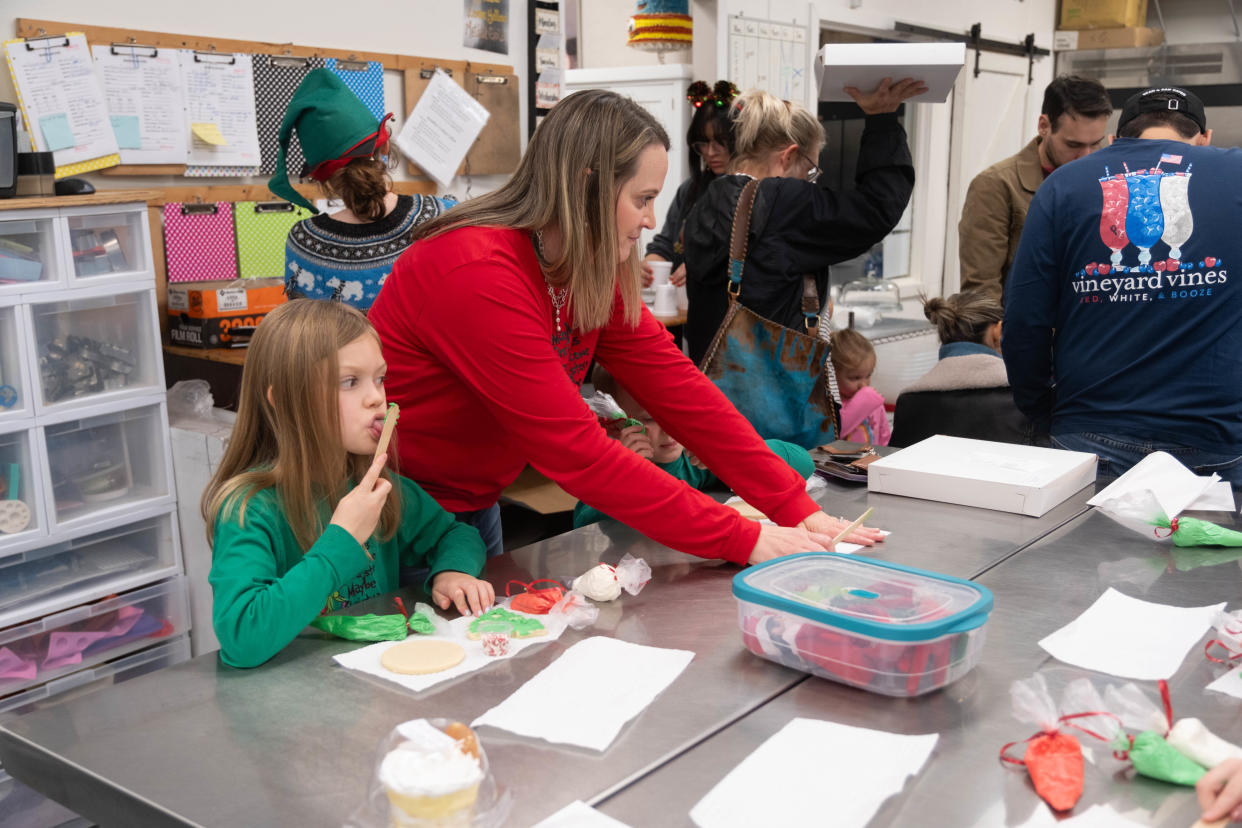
[168,279,286,348]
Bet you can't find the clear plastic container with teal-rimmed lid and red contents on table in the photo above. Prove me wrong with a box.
[733,552,992,696]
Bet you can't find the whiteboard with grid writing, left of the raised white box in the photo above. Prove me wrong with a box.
[728,15,811,103]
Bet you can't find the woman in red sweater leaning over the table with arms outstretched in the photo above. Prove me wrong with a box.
[369,91,878,564]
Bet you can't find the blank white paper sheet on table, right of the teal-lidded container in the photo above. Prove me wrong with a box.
[1040,587,1225,682]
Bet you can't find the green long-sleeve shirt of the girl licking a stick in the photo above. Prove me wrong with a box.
[207,478,486,667]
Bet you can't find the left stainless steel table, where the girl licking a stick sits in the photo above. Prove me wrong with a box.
[0,485,1089,826]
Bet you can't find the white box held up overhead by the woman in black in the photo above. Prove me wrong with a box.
[815,43,966,103]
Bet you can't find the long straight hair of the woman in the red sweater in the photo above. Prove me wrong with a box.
[415,89,668,333]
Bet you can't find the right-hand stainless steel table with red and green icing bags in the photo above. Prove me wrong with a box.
[597,511,1242,828]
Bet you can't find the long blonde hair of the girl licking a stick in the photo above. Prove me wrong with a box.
[200,299,401,552]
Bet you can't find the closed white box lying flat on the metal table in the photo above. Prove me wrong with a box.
[867,434,1097,518]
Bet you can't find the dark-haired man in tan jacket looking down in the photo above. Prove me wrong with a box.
[958,74,1113,299]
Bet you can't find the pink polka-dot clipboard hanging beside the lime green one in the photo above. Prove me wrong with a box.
[164,201,237,283]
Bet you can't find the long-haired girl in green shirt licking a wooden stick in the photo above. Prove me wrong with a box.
[202,299,494,667]
